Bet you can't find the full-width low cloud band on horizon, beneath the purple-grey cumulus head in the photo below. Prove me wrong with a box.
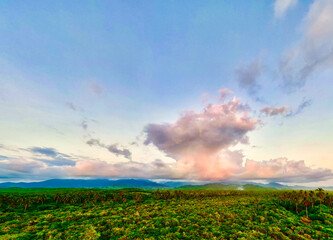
[0,144,332,182]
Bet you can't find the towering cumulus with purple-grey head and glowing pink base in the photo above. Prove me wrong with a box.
[145,98,259,179]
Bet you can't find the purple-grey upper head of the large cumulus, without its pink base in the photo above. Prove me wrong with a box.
[145,98,259,158]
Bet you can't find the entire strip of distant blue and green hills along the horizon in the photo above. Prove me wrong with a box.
[0,179,333,190]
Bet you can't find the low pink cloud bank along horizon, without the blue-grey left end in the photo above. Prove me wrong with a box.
[64,155,332,182]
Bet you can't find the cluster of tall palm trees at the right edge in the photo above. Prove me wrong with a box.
[278,188,333,217]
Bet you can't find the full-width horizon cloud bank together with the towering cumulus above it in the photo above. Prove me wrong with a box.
[0,93,332,182]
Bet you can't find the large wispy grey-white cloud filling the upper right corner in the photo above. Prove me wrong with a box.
[279,0,333,92]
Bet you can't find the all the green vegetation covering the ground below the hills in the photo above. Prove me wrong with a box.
[0,189,333,239]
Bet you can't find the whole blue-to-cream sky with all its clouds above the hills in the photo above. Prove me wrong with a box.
[0,0,333,186]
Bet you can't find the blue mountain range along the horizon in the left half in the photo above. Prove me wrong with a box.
[0,179,166,189]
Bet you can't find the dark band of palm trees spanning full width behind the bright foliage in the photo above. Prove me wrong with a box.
[0,188,333,213]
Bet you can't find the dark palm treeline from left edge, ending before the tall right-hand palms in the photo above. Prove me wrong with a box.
[0,189,275,211]
